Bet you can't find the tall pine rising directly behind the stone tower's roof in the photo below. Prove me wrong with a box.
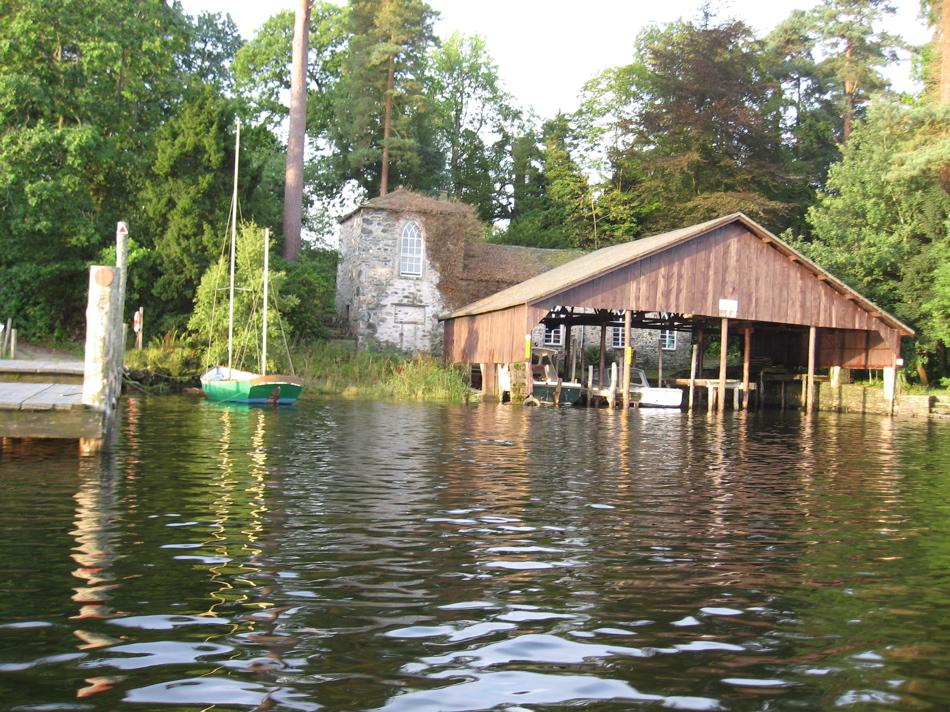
[334,0,441,194]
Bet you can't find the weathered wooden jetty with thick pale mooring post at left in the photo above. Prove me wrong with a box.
[0,223,128,453]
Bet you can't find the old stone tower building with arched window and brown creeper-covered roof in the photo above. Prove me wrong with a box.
[336,188,580,354]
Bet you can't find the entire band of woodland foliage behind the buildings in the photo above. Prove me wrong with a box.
[0,0,950,375]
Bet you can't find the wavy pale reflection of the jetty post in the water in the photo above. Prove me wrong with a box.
[70,454,123,650]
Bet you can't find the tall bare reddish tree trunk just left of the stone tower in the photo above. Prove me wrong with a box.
[284,0,310,262]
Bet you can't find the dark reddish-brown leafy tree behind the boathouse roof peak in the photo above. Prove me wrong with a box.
[588,15,793,232]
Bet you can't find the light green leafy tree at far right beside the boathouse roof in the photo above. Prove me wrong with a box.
[800,102,950,378]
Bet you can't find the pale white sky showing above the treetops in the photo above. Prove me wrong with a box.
[175,0,930,118]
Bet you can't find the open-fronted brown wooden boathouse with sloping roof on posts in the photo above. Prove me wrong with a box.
[442,213,914,410]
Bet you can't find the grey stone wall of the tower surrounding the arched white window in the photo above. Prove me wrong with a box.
[336,208,445,354]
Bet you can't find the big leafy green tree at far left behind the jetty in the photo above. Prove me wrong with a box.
[0,0,193,336]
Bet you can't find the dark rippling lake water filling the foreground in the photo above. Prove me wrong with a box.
[0,397,950,712]
